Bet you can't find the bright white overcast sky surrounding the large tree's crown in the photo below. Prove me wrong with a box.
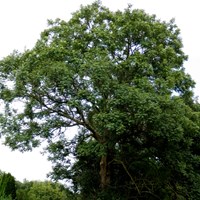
[0,0,200,181]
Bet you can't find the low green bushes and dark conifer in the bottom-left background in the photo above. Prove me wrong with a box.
[0,171,75,200]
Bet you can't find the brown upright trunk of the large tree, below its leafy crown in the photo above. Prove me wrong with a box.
[99,155,110,189]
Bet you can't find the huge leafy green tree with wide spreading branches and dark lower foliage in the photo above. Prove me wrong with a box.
[0,2,200,199]
